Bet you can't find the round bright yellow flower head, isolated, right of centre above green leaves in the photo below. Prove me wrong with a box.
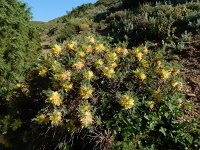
[119,95,135,109]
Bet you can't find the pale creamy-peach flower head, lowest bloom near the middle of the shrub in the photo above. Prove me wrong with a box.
[80,111,94,128]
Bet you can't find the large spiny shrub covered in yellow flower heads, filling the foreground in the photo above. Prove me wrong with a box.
[1,35,197,150]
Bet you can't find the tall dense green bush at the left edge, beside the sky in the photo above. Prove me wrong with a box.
[0,0,40,130]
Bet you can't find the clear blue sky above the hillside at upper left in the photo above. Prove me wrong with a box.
[21,0,97,22]
